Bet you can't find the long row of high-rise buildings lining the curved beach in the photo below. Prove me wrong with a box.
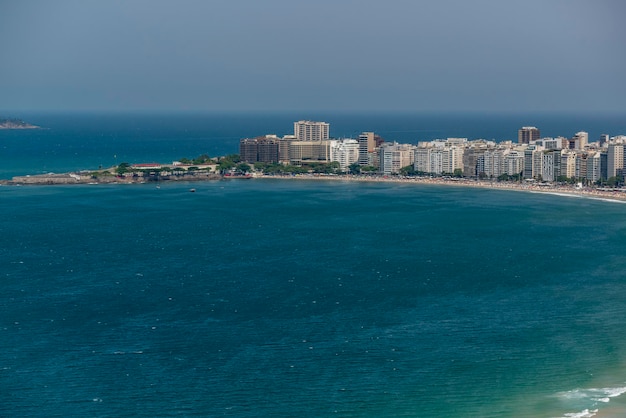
[234,120,626,182]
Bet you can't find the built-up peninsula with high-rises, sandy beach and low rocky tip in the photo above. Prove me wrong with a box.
[0,121,626,202]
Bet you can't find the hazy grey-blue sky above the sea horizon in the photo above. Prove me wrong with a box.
[0,0,626,113]
